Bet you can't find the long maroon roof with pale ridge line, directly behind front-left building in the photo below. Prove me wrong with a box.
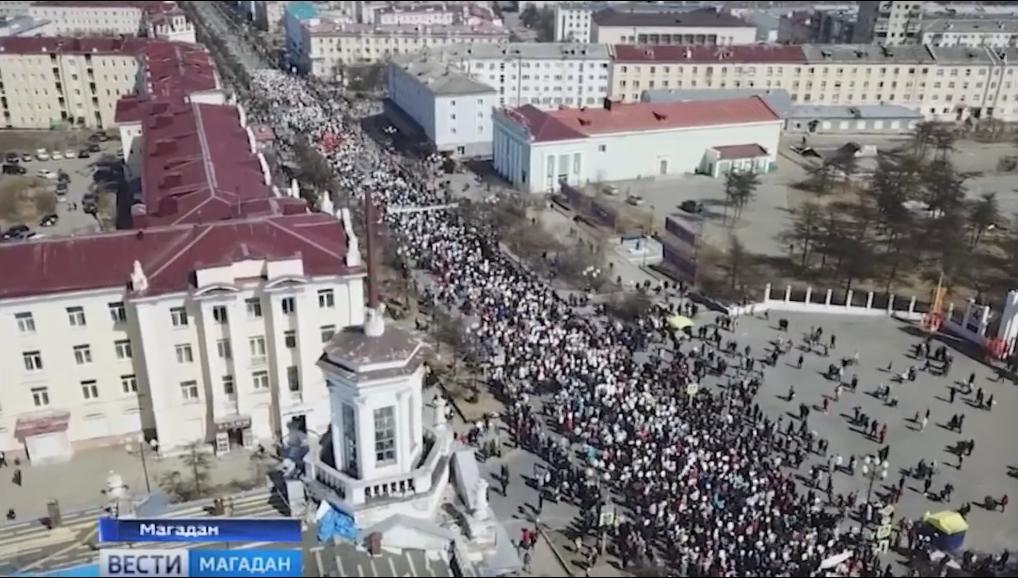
[135,102,273,227]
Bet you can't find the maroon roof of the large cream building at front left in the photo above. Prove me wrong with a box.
[0,214,357,299]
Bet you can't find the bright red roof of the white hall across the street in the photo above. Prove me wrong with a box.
[508,97,779,142]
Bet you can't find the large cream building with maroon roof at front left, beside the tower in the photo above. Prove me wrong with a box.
[0,215,363,462]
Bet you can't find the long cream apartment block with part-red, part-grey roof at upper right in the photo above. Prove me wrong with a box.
[611,45,1018,121]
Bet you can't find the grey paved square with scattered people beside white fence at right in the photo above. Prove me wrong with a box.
[716,311,1018,554]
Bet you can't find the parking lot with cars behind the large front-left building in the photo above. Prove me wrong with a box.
[0,133,120,237]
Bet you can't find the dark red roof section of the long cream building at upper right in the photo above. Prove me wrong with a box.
[615,44,806,64]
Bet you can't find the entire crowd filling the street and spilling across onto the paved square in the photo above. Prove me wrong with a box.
[248,71,1010,576]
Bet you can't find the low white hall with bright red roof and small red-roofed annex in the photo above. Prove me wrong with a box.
[493,97,782,192]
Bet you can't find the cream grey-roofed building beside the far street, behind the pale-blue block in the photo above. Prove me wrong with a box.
[287,18,509,78]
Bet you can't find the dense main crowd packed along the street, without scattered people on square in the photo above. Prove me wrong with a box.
[242,71,1005,576]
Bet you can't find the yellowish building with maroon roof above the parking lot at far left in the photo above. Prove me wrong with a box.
[0,38,219,128]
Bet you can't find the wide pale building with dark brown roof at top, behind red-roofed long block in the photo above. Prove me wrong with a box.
[590,8,756,45]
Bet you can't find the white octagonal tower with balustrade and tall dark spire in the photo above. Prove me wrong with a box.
[304,190,453,528]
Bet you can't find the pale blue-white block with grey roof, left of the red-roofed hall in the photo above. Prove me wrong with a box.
[386,55,499,157]
